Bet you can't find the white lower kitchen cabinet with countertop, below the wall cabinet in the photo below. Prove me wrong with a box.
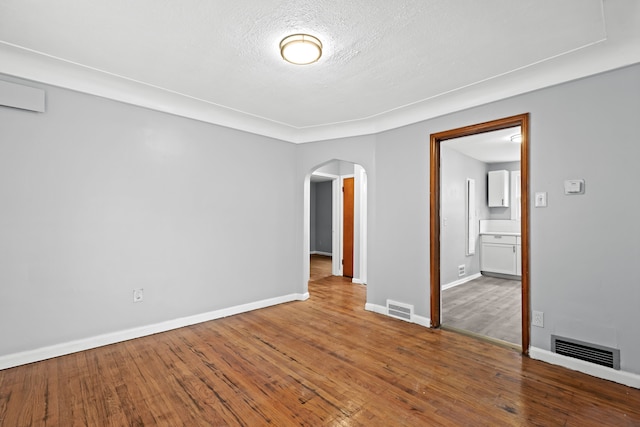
[480,234,522,276]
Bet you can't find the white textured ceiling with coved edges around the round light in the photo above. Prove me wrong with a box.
[0,0,640,142]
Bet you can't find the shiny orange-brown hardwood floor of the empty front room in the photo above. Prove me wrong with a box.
[0,270,640,427]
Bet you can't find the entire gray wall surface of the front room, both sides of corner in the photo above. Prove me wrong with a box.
[5,65,640,373]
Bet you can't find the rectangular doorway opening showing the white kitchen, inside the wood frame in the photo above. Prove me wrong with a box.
[440,127,522,347]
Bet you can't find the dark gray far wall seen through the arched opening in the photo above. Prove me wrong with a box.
[310,181,333,254]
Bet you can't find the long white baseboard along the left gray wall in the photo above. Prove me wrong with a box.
[0,292,309,370]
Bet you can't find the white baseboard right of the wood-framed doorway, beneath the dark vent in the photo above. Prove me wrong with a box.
[529,347,640,388]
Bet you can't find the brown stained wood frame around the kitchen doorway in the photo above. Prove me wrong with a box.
[430,113,531,355]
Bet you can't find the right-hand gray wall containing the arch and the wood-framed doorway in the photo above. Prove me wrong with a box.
[297,65,640,373]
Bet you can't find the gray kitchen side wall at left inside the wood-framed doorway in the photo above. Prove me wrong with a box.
[440,146,489,285]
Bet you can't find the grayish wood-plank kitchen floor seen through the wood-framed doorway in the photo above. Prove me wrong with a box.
[442,276,522,346]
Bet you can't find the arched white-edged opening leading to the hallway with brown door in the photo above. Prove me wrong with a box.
[305,160,367,285]
